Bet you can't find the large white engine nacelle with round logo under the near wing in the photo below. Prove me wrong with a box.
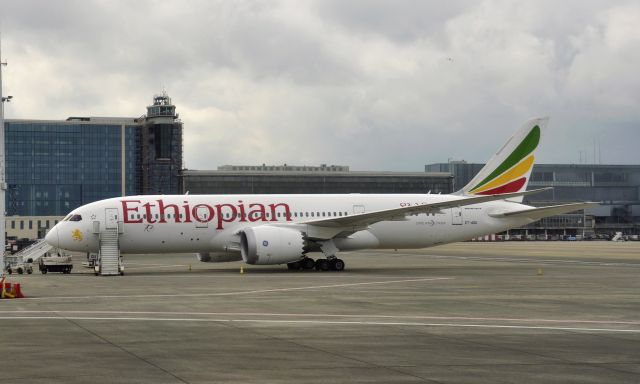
[240,225,305,265]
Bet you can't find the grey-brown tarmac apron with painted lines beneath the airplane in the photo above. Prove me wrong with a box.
[0,242,640,383]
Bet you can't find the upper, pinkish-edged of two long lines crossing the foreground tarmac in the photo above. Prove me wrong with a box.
[0,310,640,325]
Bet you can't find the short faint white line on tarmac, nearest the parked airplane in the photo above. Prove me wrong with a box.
[10,277,453,300]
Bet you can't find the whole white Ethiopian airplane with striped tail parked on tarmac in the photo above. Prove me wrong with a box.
[45,118,597,271]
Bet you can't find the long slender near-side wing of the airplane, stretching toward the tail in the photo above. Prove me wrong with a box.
[299,188,552,228]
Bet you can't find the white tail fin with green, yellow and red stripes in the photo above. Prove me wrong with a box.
[456,118,549,202]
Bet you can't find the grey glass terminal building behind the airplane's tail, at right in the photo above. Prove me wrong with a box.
[425,161,640,238]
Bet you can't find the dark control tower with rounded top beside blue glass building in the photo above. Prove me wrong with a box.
[140,92,183,194]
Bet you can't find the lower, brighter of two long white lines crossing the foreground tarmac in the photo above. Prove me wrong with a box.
[0,316,640,334]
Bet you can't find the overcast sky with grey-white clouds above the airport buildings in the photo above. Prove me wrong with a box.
[0,0,640,171]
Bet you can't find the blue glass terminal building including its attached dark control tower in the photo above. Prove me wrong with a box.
[5,94,182,238]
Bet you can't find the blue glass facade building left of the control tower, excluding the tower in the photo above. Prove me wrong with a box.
[5,121,139,216]
